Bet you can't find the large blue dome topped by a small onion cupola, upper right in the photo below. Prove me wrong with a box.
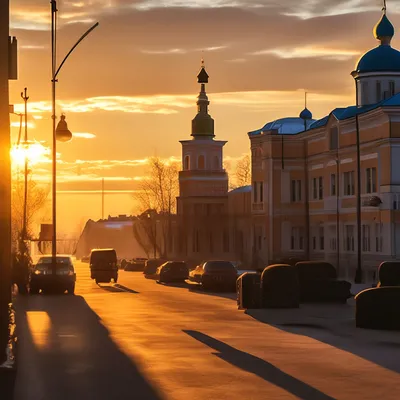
[356,10,400,73]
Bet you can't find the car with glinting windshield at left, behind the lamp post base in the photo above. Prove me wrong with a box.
[29,255,76,294]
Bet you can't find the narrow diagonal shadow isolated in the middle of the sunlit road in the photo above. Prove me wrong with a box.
[184,330,334,400]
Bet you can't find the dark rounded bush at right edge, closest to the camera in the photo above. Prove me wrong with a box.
[355,286,400,330]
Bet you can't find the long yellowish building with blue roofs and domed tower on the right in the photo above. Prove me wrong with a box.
[248,10,400,281]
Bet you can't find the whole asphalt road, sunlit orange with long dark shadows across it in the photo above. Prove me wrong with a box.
[15,263,400,400]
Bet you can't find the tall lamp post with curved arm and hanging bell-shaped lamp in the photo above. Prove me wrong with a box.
[50,0,99,268]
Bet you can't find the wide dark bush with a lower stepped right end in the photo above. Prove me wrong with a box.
[296,261,351,303]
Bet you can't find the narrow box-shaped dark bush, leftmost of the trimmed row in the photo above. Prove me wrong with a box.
[236,272,262,310]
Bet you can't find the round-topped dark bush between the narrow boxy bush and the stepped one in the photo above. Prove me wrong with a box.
[261,264,299,308]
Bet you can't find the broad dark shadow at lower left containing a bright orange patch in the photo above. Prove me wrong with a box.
[15,296,162,400]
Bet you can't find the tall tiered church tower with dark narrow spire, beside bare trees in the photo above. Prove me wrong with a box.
[177,60,229,259]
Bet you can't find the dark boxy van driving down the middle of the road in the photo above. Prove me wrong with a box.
[90,249,118,283]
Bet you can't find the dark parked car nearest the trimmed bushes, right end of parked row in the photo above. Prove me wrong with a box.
[189,261,238,291]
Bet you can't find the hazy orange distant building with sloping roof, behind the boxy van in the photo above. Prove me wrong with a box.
[76,215,146,259]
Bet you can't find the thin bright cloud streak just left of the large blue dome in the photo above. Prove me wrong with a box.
[250,46,361,60]
